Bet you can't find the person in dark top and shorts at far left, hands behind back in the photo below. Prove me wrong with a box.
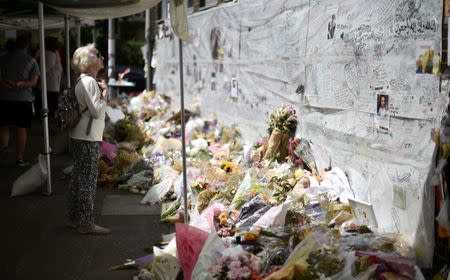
[0,35,40,166]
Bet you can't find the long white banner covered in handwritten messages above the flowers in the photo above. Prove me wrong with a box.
[155,0,442,267]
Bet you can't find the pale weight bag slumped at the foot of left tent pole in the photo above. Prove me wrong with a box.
[11,154,48,197]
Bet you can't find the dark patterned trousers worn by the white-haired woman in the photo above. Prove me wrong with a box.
[68,139,100,225]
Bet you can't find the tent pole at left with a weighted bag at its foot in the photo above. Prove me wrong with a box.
[38,2,52,195]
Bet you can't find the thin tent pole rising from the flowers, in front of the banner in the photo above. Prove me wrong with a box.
[178,39,189,224]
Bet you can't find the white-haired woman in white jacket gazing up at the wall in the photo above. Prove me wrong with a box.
[67,44,110,234]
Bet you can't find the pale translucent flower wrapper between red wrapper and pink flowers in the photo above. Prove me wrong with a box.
[192,233,227,280]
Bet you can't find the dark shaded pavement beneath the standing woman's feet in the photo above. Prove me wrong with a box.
[0,121,173,280]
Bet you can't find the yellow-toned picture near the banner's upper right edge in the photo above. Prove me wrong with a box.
[416,41,441,74]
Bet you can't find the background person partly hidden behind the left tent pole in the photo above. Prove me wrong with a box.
[45,37,63,117]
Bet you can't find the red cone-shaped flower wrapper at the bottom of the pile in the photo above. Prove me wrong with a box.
[175,223,208,280]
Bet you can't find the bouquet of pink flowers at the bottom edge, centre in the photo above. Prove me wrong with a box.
[209,251,262,280]
